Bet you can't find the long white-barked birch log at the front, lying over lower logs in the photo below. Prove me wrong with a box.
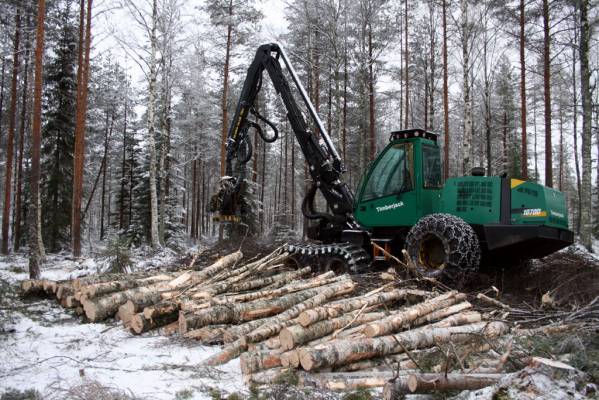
[299,322,509,371]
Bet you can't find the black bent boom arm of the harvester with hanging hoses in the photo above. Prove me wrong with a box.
[226,44,357,241]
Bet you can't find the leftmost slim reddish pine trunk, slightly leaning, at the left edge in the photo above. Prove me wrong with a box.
[2,8,21,254]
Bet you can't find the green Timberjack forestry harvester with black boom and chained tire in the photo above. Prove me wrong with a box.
[211,44,573,279]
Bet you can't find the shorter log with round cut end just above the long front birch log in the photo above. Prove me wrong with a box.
[279,311,387,350]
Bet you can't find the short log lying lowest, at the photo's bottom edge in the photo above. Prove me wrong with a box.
[383,373,504,400]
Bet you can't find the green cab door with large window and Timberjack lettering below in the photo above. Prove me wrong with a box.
[355,142,420,228]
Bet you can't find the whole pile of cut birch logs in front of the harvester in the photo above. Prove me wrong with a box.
[22,249,524,398]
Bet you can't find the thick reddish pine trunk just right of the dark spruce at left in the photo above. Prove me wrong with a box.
[71,0,92,257]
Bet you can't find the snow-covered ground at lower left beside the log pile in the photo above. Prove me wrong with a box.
[0,252,244,399]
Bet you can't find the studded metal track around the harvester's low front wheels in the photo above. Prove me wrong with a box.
[284,243,371,274]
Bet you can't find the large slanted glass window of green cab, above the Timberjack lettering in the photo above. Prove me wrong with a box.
[362,143,414,201]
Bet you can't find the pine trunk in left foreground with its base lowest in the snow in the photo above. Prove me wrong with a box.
[28,0,46,279]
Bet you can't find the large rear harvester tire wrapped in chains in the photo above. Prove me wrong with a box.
[405,214,480,284]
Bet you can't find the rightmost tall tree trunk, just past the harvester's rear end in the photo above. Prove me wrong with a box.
[580,0,593,252]
